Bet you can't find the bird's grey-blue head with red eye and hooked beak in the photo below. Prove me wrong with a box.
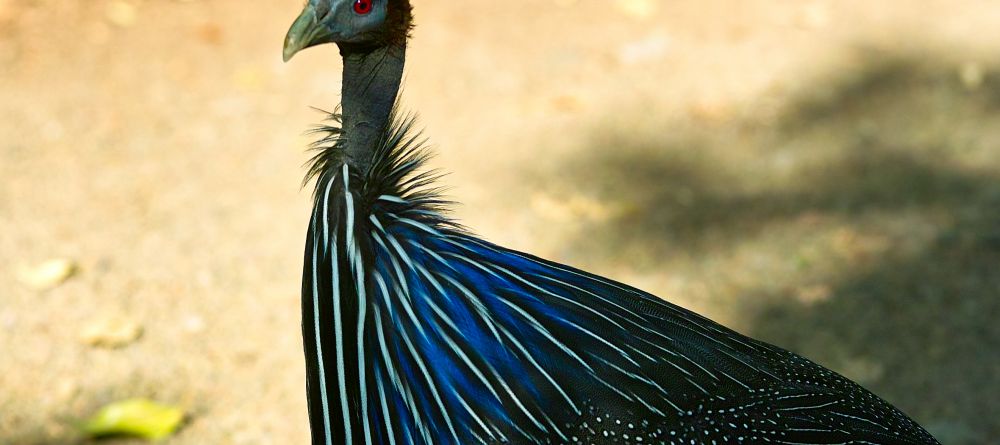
[283,0,411,62]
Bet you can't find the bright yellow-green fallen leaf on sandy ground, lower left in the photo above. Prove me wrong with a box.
[81,399,184,440]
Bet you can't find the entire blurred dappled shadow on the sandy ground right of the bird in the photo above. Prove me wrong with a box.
[530,54,1000,444]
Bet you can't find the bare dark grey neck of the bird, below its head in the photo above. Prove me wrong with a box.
[340,41,406,171]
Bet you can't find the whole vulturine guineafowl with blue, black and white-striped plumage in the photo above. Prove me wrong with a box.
[283,0,938,445]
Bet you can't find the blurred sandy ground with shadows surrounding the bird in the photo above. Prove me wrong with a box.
[0,0,1000,445]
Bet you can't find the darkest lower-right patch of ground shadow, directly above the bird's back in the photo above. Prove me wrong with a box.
[746,197,1000,443]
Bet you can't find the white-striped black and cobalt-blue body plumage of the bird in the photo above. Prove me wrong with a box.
[300,150,940,445]
